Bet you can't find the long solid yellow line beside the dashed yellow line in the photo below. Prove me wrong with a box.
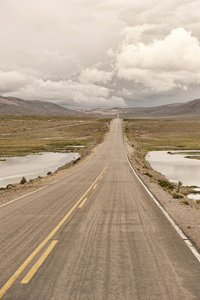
[0,167,106,299]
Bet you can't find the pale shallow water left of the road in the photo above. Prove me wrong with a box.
[0,152,79,187]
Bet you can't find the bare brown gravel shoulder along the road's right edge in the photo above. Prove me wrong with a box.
[124,135,200,250]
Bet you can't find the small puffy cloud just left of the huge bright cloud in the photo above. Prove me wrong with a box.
[79,68,113,84]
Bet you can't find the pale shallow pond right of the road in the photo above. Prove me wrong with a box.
[146,151,200,187]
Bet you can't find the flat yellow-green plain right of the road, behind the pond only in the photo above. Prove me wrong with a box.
[124,119,200,156]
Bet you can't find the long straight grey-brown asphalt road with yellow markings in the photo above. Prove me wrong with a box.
[0,119,200,300]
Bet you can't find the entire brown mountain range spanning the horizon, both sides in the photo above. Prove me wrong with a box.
[0,96,200,119]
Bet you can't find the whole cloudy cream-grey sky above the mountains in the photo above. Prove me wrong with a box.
[0,0,200,108]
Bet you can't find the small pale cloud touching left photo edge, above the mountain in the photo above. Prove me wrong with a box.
[0,71,33,93]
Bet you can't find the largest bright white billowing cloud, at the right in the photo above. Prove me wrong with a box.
[117,28,200,92]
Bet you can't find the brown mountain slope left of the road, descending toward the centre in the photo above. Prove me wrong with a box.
[0,96,79,116]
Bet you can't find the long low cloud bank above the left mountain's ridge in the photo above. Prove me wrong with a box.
[6,79,126,108]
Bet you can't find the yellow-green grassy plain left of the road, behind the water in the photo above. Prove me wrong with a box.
[0,114,110,157]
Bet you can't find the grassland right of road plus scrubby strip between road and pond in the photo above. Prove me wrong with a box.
[123,119,200,204]
